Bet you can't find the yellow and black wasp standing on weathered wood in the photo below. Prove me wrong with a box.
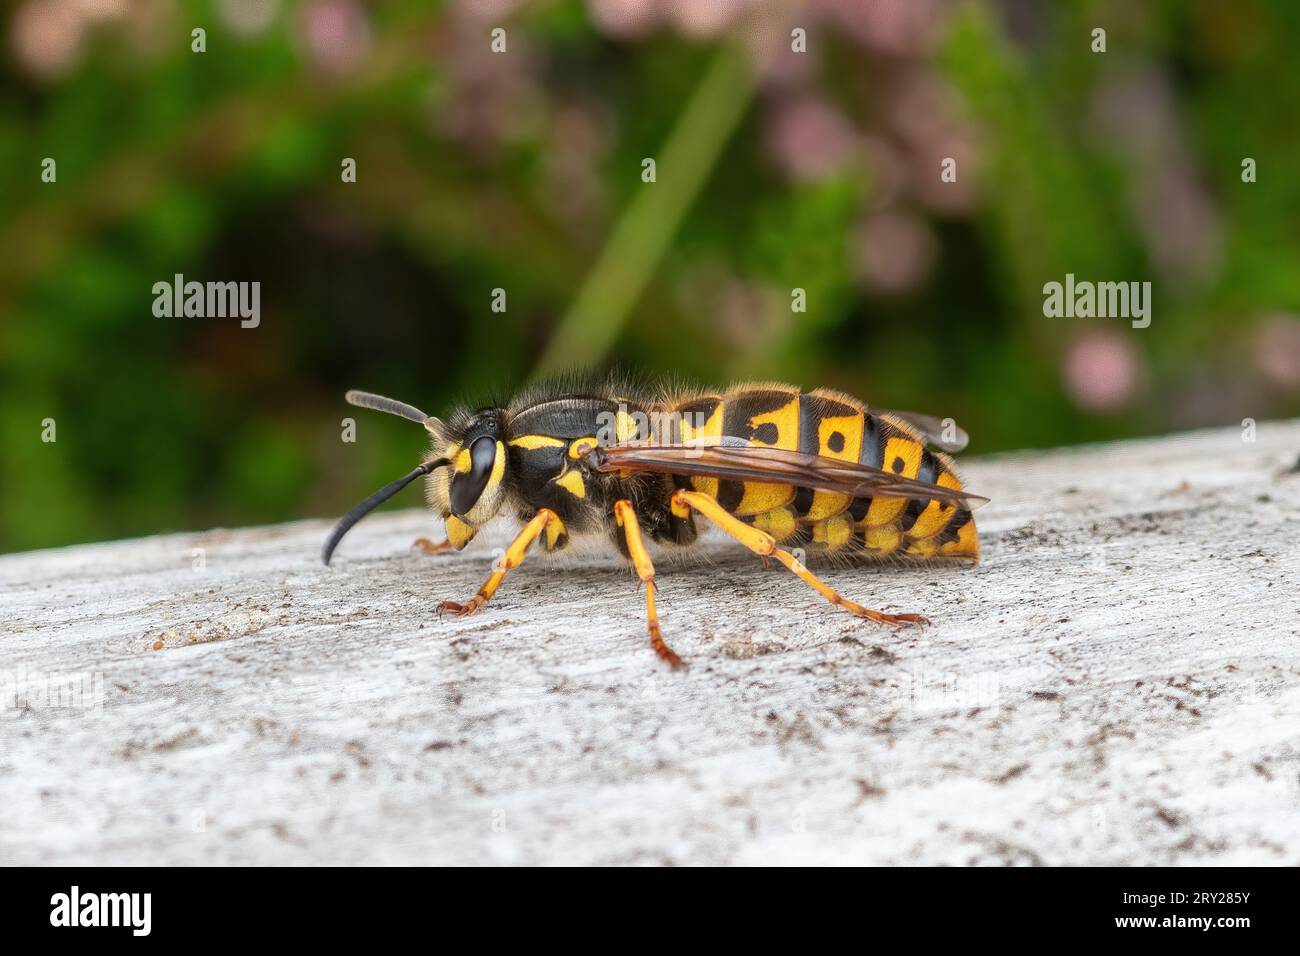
[322,380,985,667]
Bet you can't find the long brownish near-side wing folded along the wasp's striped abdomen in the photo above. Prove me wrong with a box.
[588,442,988,509]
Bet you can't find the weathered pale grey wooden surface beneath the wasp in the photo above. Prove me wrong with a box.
[0,423,1300,865]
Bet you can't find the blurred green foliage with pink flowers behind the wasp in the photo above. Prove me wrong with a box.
[0,0,1300,550]
